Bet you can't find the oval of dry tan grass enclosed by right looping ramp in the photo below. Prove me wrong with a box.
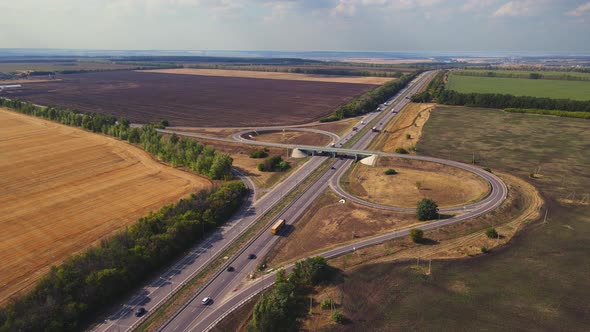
[342,158,489,208]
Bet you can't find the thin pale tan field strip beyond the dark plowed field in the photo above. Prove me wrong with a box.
[140,68,395,85]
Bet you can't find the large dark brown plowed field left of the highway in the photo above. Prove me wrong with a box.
[5,71,377,127]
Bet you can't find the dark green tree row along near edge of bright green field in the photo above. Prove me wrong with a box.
[412,71,590,112]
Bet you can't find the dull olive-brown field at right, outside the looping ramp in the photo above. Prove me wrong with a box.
[326,107,590,331]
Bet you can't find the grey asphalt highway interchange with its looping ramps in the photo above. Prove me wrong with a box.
[94,72,507,331]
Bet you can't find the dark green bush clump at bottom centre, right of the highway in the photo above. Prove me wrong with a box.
[247,256,333,332]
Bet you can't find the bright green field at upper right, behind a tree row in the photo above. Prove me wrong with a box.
[447,73,590,100]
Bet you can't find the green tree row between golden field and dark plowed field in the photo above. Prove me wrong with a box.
[0,98,233,180]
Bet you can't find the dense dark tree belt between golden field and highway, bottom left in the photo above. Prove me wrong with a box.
[0,182,248,331]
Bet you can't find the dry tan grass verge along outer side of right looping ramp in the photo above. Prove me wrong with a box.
[303,174,543,331]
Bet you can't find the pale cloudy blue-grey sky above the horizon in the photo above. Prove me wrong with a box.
[0,0,590,53]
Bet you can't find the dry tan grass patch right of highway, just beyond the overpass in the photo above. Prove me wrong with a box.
[369,103,435,152]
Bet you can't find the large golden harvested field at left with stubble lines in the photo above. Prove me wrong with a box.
[0,110,211,303]
